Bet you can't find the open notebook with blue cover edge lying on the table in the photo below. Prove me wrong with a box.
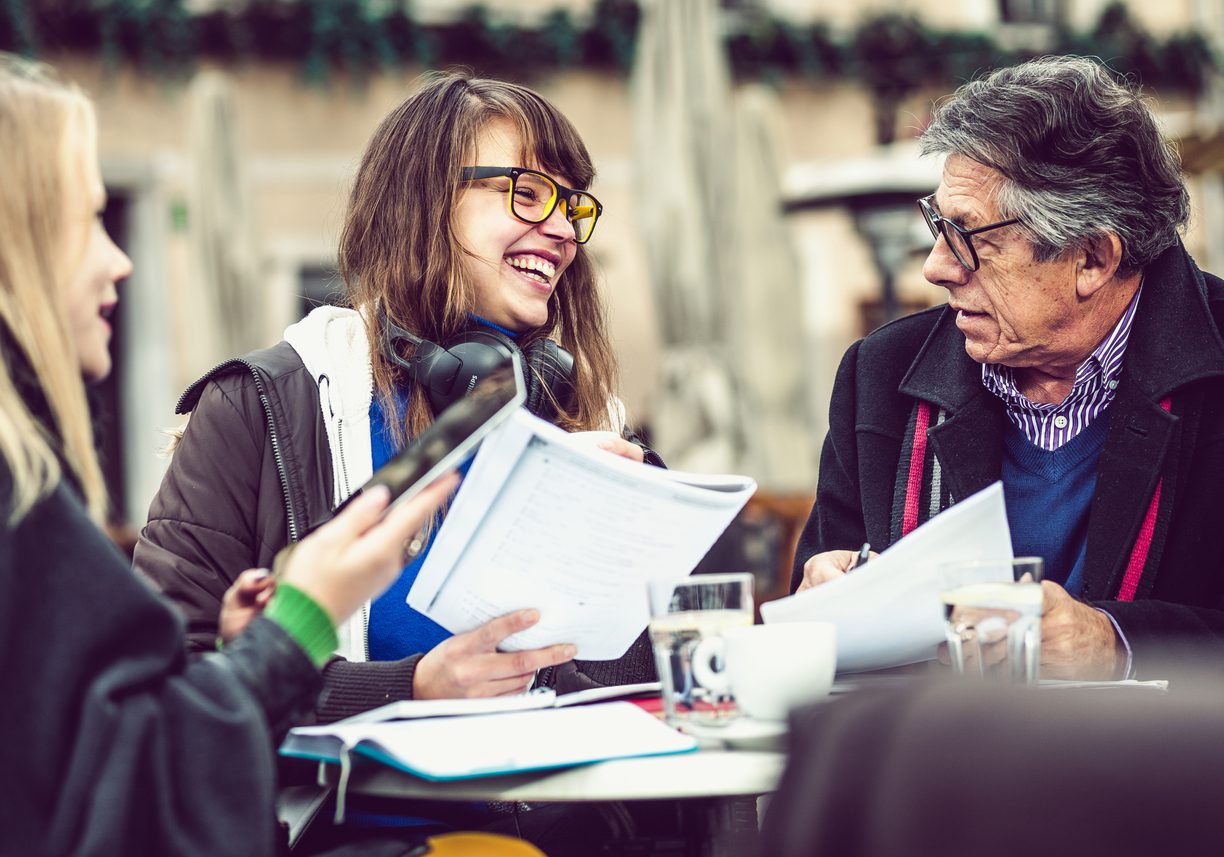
[280,703,696,781]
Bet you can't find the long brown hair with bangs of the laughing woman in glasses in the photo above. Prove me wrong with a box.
[339,72,619,440]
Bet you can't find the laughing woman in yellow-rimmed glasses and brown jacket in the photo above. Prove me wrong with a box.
[136,67,654,768]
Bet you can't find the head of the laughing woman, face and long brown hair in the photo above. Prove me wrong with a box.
[339,75,623,435]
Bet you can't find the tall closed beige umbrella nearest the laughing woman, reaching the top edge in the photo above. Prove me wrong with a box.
[632,0,744,471]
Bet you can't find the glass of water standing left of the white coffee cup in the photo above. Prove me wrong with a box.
[647,573,753,726]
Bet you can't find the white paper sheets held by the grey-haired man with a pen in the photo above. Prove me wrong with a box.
[761,482,1012,672]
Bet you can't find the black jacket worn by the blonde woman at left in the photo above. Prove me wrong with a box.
[0,468,318,857]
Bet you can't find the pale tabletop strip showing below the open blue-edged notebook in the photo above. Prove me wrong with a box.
[323,749,786,802]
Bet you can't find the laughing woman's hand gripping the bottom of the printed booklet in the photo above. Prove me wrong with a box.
[412,610,578,699]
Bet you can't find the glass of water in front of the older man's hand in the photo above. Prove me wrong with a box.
[939,557,1044,684]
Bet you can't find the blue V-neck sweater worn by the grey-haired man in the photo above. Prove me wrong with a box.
[1002,410,1109,595]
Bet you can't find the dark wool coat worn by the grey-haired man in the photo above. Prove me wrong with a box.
[792,244,1224,677]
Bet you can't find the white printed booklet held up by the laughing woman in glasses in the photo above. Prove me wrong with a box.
[408,410,756,660]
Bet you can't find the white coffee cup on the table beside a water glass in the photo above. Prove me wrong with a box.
[693,622,837,720]
